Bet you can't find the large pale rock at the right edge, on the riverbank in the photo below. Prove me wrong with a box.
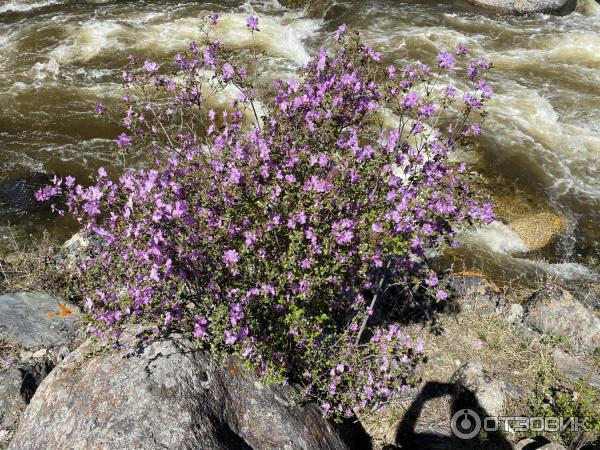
[524,286,600,353]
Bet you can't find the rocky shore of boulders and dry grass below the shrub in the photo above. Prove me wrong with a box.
[0,237,600,449]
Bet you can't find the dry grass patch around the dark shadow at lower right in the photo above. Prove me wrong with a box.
[363,310,553,448]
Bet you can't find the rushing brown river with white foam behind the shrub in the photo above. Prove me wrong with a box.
[0,0,600,284]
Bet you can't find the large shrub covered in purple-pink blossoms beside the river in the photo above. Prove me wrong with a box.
[38,15,492,417]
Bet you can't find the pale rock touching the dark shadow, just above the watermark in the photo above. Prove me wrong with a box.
[452,361,505,416]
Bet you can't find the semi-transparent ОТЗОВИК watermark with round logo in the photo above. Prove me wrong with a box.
[450,409,588,439]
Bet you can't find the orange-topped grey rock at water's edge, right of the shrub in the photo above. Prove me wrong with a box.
[448,272,505,314]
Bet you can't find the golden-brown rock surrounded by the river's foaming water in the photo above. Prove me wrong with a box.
[508,211,565,250]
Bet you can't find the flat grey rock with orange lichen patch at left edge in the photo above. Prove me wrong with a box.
[0,292,79,349]
